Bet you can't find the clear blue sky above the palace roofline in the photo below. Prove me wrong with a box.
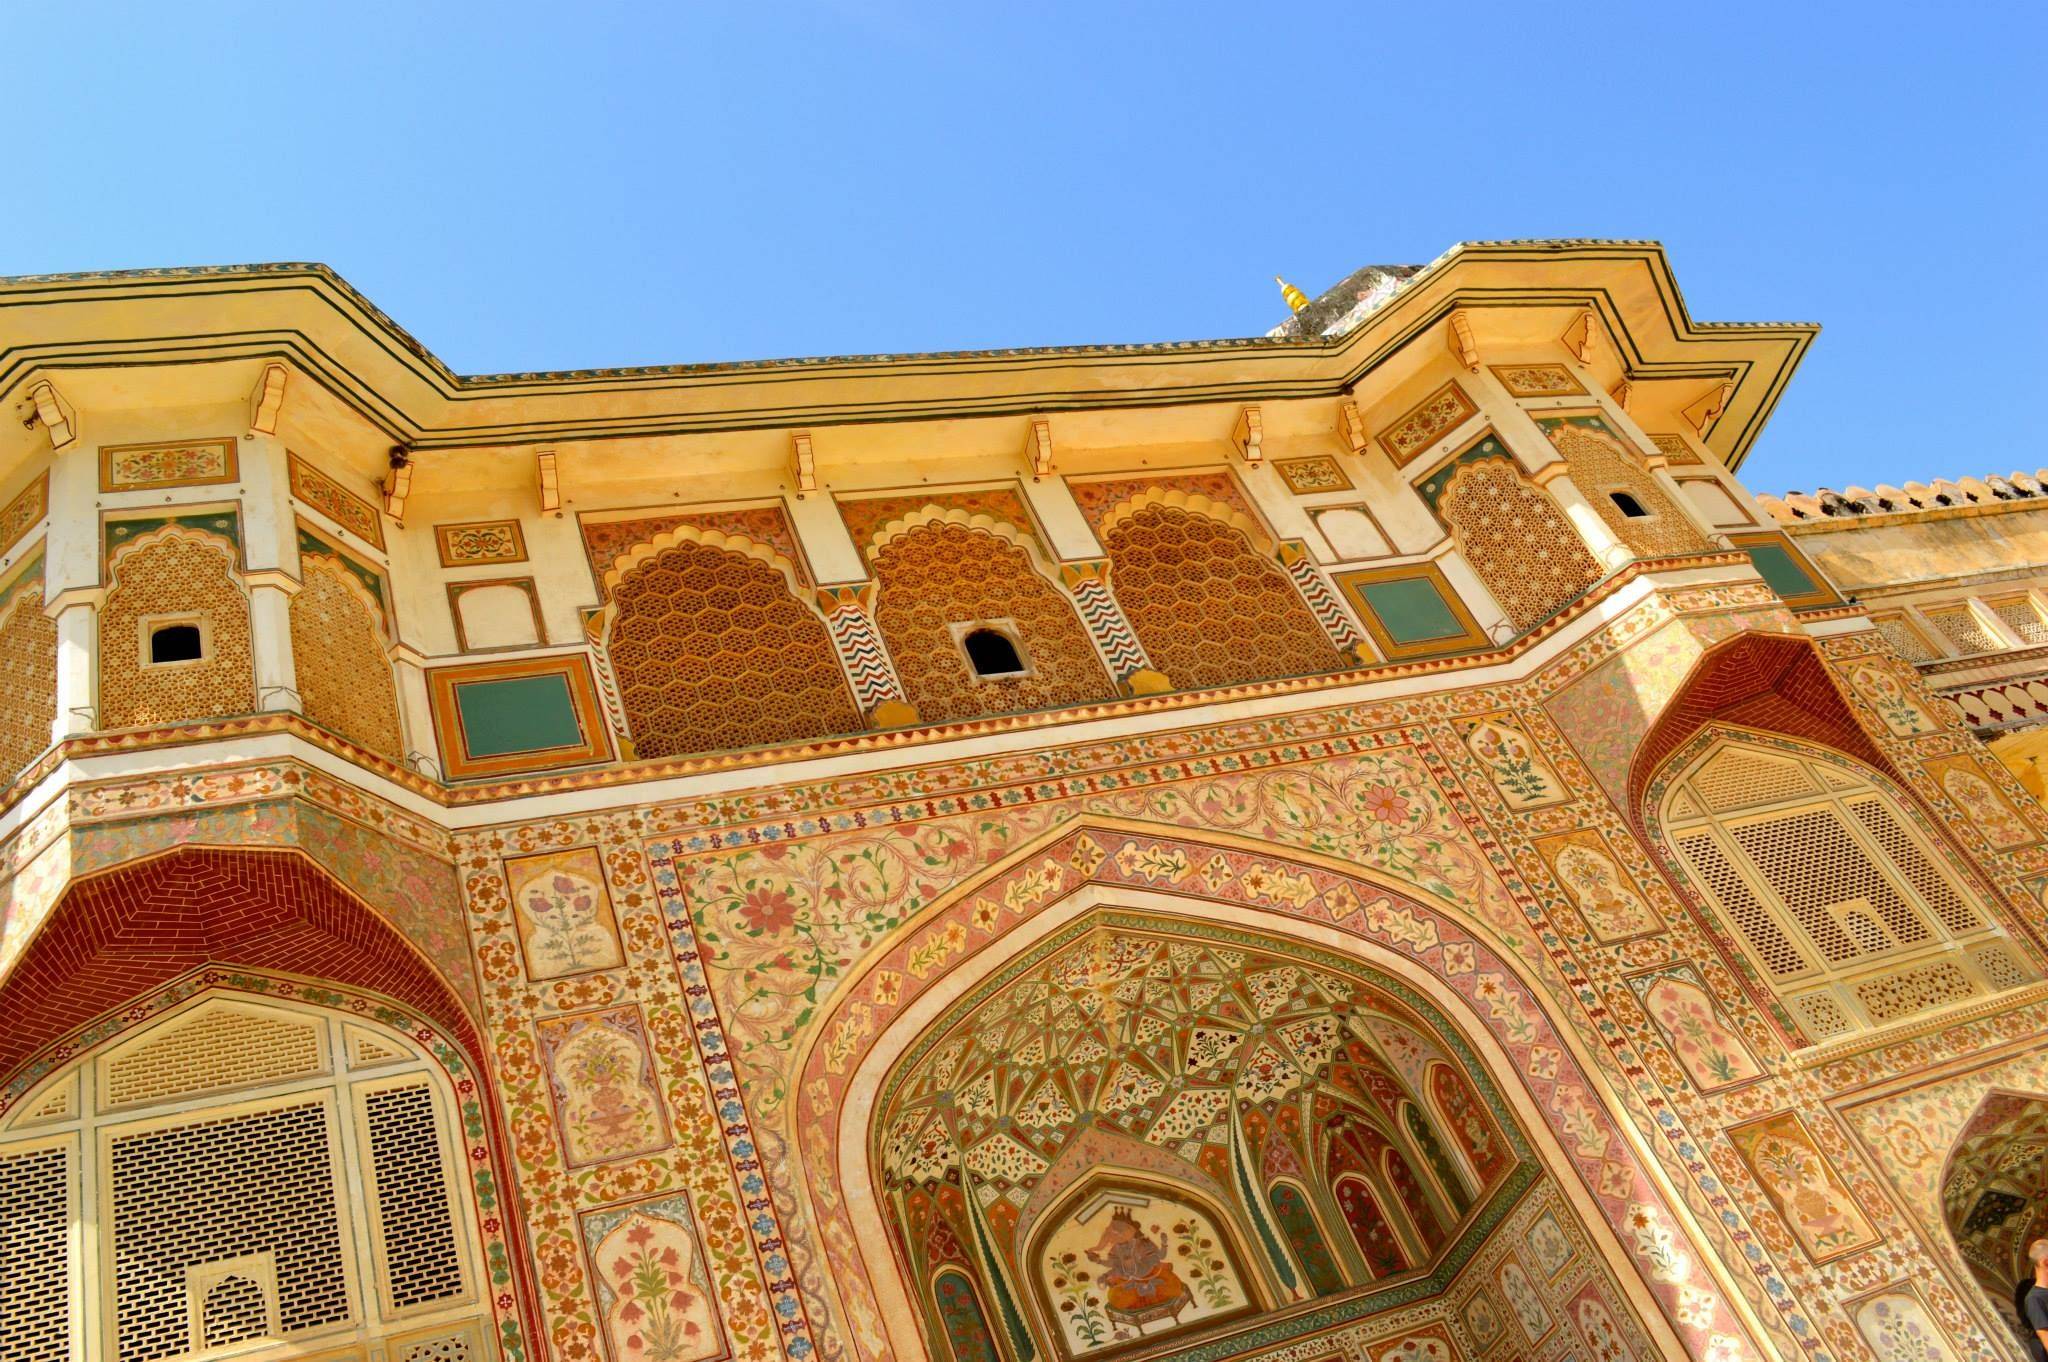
[0,0,2048,490]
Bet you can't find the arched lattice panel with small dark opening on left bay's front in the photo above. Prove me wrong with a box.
[98,524,256,729]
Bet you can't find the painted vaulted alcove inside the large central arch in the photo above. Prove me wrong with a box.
[870,913,1534,1362]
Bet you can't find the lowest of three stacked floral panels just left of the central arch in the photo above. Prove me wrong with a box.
[584,1196,725,1362]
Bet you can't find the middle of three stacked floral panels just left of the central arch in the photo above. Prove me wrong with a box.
[535,1008,668,1167]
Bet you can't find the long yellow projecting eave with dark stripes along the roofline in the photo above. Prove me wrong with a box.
[0,242,1819,467]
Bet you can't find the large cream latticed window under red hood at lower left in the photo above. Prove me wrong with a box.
[0,997,485,1362]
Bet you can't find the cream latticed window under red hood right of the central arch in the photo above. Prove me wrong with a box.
[1663,739,2034,1040]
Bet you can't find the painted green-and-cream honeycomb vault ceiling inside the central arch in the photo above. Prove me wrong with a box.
[883,930,1515,1204]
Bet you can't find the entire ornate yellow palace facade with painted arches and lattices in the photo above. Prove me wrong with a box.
[0,242,2048,1362]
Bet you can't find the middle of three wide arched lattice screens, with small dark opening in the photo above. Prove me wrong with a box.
[870,508,1116,723]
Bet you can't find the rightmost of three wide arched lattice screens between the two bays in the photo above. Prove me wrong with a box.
[1102,498,1346,690]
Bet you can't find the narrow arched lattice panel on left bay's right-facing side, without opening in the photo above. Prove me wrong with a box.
[291,553,406,762]
